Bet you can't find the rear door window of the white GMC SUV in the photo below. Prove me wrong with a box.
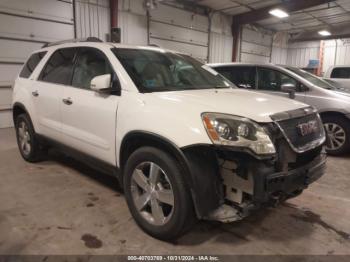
[39,48,77,85]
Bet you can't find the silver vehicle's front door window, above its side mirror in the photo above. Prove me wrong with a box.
[258,68,297,91]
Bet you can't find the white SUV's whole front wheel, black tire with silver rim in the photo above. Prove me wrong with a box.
[124,147,195,240]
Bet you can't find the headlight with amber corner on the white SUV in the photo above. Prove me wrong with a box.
[202,113,276,155]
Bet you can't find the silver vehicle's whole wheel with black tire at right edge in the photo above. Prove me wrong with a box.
[322,115,350,156]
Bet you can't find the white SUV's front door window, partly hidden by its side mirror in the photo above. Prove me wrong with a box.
[72,48,113,89]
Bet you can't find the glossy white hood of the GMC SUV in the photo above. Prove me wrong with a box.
[152,89,307,123]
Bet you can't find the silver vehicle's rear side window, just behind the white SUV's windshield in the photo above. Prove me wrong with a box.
[214,66,256,89]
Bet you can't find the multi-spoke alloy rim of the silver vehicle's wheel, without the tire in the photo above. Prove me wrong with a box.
[324,123,346,151]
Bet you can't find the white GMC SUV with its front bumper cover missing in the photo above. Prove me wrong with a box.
[13,37,325,239]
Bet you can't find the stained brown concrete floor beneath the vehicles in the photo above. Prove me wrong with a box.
[0,129,350,255]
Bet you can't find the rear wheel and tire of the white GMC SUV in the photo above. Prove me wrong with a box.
[15,114,47,163]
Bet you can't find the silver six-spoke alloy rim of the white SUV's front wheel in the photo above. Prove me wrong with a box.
[131,162,174,226]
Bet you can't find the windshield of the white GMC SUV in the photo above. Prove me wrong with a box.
[112,48,233,92]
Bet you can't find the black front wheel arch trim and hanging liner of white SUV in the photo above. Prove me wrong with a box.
[119,131,219,218]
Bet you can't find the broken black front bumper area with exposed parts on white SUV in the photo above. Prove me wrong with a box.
[184,145,326,221]
